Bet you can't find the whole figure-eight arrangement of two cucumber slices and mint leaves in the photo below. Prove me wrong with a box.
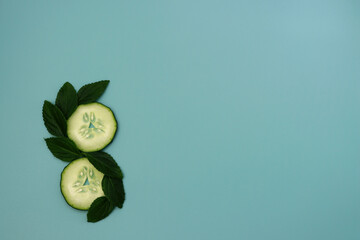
[42,80,125,222]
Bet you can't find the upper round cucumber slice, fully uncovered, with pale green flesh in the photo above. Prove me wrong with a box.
[67,103,117,152]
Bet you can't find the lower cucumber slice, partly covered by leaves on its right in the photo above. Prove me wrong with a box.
[60,158,104,210]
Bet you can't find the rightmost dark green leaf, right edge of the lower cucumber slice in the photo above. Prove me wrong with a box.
[101,175,125,208]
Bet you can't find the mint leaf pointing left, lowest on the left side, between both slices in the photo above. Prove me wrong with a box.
[45,137,82,162]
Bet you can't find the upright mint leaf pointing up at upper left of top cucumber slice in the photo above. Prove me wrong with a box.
[55,82,77,119]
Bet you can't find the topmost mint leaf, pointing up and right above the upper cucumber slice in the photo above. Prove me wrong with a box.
[77,80,110,104]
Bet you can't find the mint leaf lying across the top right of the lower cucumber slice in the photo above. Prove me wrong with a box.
[84,152,123,178]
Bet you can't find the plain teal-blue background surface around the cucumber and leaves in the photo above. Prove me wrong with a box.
[0,0,360,240]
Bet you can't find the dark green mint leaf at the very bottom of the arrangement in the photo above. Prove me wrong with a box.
[87,197,115,222]
